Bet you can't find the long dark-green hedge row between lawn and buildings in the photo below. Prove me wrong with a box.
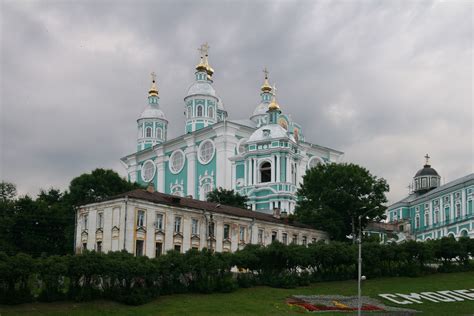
[0,238,474,305]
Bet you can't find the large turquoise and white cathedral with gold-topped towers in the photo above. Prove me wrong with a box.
[121,44,343,213]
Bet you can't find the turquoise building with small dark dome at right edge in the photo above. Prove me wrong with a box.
[385,155,474,241]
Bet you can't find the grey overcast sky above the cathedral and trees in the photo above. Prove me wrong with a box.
[0,0,474,202]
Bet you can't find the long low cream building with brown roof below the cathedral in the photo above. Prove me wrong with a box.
[75,189,328,258]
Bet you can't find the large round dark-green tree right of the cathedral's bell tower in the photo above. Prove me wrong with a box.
[295,163,389,241]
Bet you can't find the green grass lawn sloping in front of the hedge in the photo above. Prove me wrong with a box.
[0,272,474,316]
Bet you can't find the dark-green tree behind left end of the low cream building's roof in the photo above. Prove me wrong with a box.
[66,169,141,206]
